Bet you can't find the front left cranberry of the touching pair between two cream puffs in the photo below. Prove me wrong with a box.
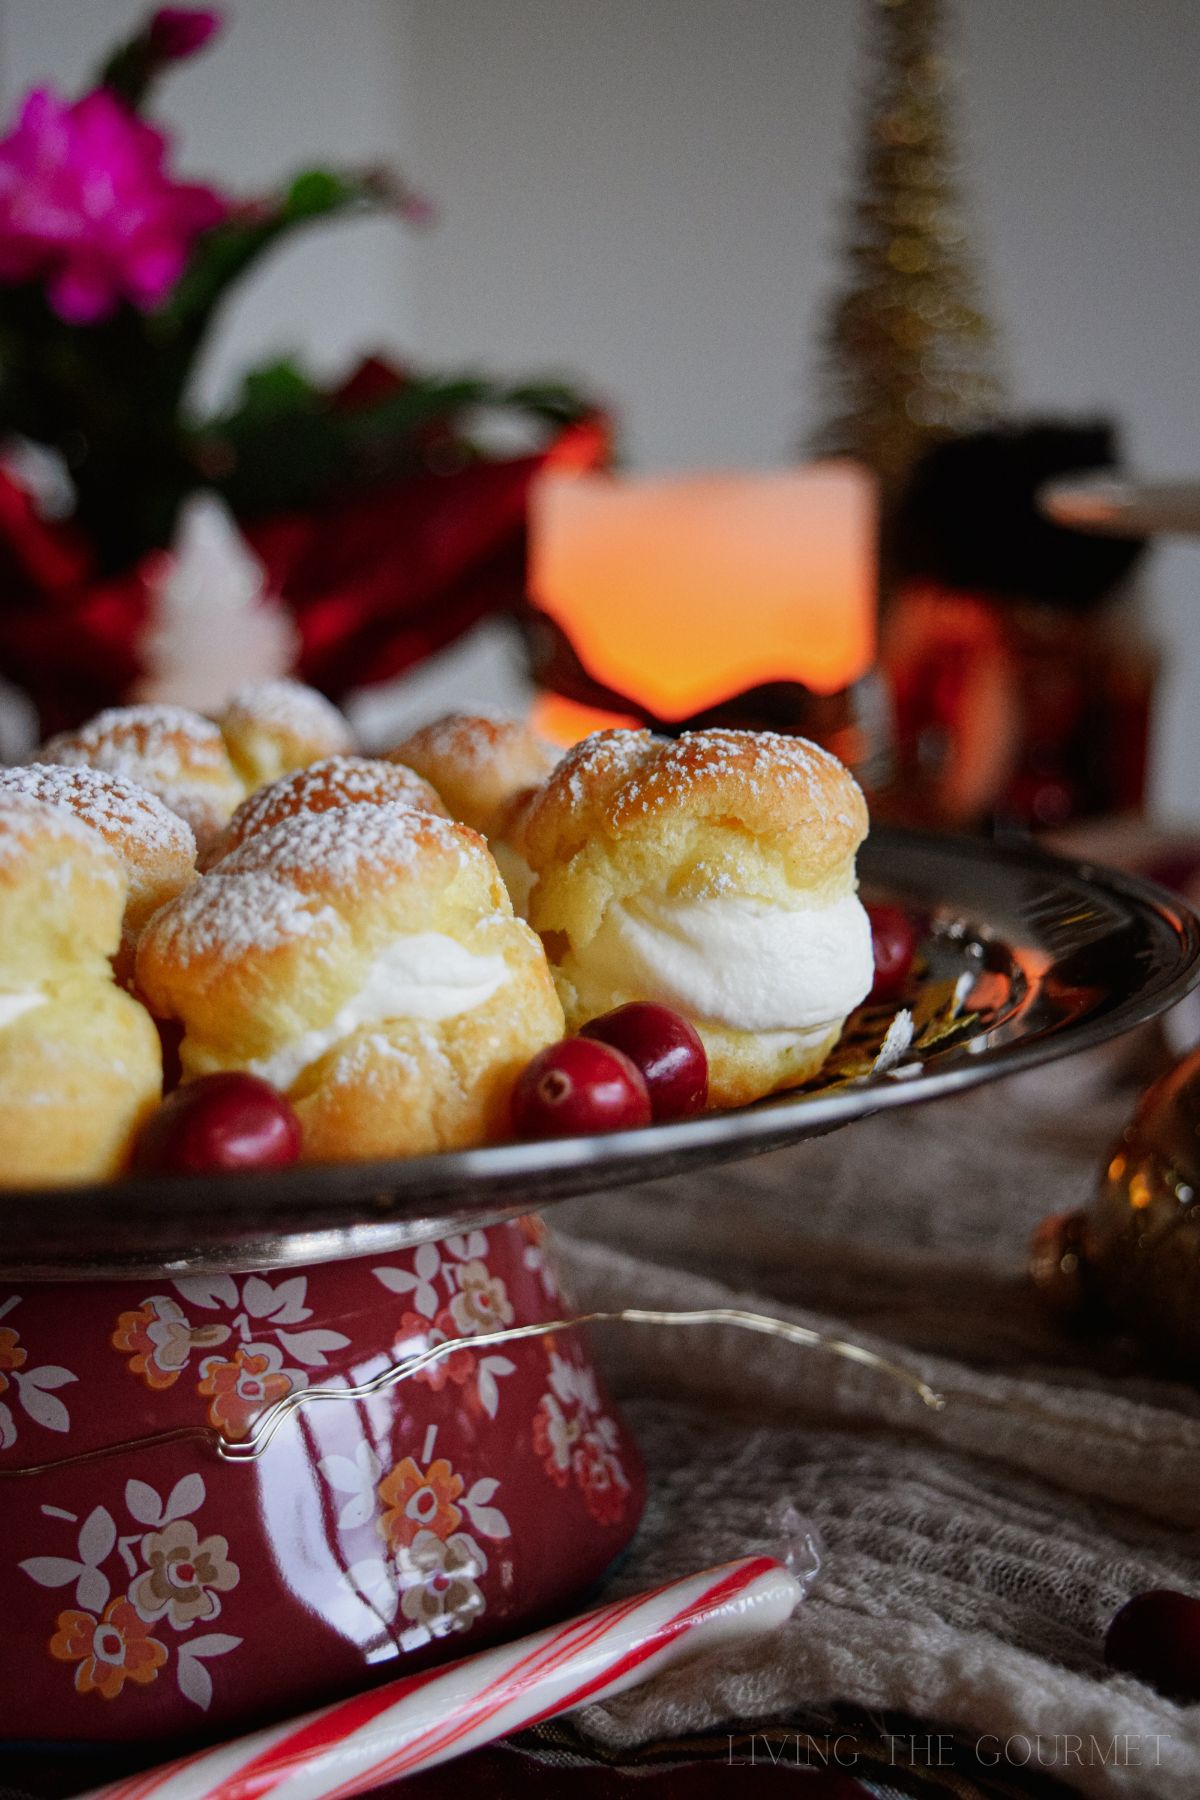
[513,1037,649,1138]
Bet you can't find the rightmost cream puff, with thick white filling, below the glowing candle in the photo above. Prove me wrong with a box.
[524,731,873,1107]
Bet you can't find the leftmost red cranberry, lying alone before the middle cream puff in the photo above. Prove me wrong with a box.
[133,1073,300,1175]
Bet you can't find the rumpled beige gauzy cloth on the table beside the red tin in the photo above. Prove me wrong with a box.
[554,1062,1200,1800]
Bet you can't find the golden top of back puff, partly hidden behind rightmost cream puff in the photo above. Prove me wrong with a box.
[387,713,558,837]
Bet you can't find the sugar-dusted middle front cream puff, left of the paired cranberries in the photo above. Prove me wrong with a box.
[137,803,563,1161]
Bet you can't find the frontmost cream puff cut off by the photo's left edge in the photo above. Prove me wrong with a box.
[0,792,162,1188]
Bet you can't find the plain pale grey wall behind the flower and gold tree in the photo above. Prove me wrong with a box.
[0,0,1200,815]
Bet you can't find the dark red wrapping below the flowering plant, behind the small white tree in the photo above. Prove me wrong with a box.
[0,401,608,734]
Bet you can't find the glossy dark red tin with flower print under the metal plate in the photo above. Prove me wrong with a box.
[0,1219,642,1742]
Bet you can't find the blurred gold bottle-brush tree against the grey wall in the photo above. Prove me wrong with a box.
[813,0,1002,499]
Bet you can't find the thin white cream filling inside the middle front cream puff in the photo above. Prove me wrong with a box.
[246,931,509,1093]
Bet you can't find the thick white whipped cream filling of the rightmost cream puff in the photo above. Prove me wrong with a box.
[569,895,874,1044]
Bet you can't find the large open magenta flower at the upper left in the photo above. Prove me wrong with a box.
[0,88,227,324]
